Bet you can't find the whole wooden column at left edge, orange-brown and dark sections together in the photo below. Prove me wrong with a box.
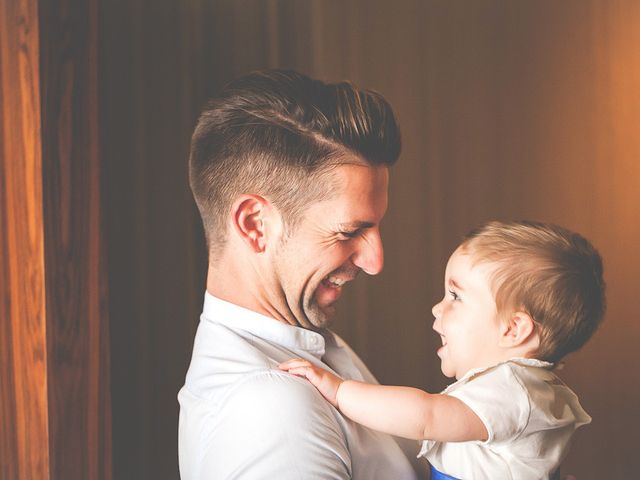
[0,0,111,480]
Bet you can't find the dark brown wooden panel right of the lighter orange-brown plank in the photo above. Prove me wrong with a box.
[39,0,111,480]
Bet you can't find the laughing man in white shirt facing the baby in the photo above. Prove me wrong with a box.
[178,71,415,480]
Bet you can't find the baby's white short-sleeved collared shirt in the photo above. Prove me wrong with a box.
[419,358,591,480]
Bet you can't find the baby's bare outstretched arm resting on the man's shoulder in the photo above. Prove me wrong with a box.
[280,360,488,442]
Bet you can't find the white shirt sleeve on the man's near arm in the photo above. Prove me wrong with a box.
[201,370,351,480]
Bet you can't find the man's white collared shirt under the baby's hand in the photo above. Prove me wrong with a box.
[178,293,415,480]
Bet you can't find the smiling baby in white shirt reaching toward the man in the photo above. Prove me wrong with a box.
[280,222,605,480]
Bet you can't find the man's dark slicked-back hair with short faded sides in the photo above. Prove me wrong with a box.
[189,70,400,256]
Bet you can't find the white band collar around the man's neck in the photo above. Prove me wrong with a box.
[202,292,325,359]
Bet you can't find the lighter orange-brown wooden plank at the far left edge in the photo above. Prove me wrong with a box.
[0,0,49,480]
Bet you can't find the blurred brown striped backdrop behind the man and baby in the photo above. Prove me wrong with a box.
[3,0,640,480]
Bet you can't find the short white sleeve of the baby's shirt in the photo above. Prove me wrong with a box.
[447,364,531,443]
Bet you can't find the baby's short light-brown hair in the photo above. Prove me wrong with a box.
[461,221,605,362]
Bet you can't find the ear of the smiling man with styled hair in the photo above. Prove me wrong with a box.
[231,195,273,253]
